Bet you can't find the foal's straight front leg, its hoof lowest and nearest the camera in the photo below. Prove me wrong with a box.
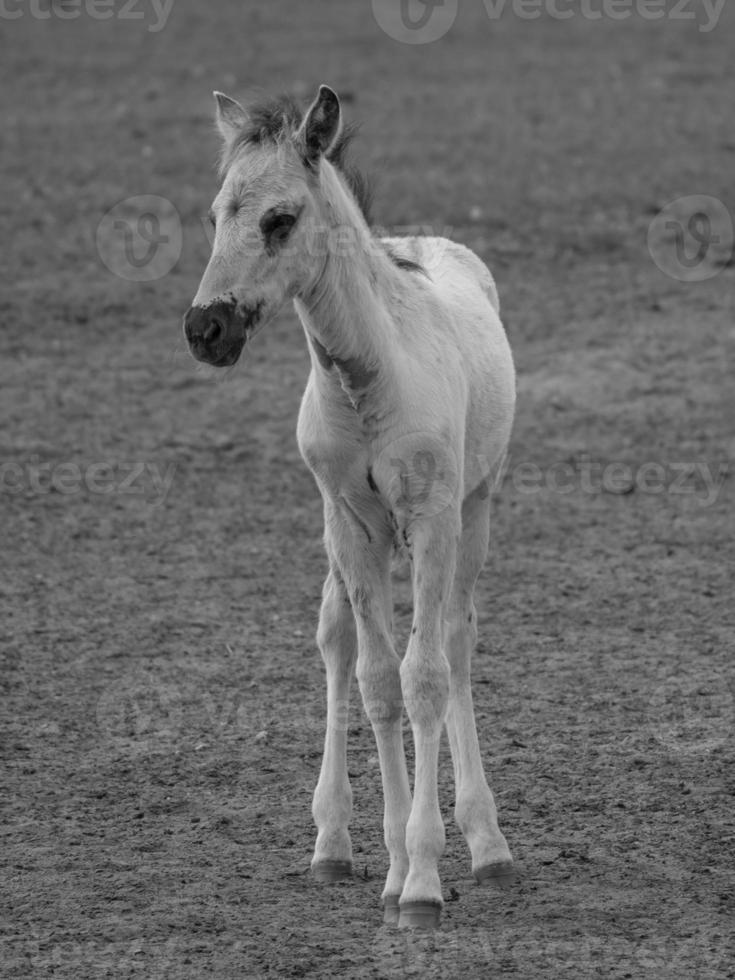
[399,510,460,928]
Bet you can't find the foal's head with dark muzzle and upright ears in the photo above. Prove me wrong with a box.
[184,85,362,367]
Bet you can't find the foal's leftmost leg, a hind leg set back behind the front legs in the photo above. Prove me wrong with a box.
[311,544,357,881]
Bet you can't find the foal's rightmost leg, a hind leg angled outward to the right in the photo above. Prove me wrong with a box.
[446,488,514,884]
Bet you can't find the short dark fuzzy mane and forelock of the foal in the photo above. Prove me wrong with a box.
[220,95,372,225]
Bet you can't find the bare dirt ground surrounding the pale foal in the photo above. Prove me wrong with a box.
[0,0,735,980]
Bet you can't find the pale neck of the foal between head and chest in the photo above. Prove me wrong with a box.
[295,161,398,387]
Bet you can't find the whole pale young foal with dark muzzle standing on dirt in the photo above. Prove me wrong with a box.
[184,85,515,927]
